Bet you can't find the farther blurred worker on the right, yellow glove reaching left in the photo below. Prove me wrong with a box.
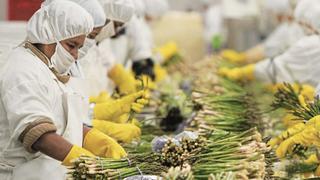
[221,0,304,64]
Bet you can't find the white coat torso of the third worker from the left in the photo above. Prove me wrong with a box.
[78,45,114,97]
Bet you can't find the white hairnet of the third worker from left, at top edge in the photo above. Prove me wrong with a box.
[100,0,134,23]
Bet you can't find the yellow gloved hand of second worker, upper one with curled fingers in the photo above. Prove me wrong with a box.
[93,91,148,120]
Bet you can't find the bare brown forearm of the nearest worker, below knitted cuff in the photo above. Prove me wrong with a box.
[32,132,73,161]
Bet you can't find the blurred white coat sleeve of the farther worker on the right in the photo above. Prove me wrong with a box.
[263,22,305,58]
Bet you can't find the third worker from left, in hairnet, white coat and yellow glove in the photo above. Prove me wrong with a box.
[80,0,136,96]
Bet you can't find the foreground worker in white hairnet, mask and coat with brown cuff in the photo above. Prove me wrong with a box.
[0,0,126,180]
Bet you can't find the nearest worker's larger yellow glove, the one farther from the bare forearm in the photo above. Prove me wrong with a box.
[83,129,127,159]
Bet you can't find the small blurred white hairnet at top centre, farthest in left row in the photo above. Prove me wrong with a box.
[144,0,169,18]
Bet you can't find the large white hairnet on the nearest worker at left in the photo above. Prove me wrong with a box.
[27,0,93,44]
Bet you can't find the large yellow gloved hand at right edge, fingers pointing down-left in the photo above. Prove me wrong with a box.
[276,115,320,158]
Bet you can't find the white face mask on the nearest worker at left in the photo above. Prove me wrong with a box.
[51,42,76,74]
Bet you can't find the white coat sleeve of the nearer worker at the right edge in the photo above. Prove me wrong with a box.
[255,35,320,86]
